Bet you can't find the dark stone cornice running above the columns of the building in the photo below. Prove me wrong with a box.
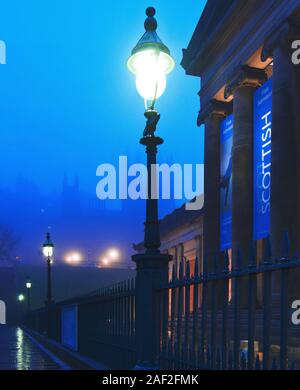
[186,0,300,109]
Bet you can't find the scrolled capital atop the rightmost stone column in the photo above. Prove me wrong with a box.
[260,20,300,62]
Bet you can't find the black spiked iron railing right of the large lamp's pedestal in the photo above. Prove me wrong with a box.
[158,236,300,370]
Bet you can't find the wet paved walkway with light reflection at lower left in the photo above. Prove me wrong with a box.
[0,325,62,370]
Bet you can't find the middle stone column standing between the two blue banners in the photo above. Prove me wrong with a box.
[225,65,267,305]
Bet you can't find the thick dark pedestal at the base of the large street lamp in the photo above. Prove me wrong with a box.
[132,253,172,369]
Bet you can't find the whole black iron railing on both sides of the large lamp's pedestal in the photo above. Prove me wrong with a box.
[27,233,300,370]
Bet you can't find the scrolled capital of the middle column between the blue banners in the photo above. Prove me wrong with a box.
[224,65,268,99]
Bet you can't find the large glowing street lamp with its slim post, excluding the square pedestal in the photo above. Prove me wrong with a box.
[127,7,175,253]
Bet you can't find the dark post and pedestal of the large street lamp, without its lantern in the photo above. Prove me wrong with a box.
[132,111,172,369]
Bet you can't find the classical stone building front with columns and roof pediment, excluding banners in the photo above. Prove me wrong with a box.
[182,0,300,299]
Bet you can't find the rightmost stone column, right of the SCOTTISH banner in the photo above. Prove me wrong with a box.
[262,23,300,299]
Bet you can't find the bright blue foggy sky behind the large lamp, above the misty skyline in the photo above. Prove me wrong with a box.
[0,0,205,264]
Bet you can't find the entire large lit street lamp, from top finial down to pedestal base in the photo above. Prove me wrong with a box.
[127,7,175,368]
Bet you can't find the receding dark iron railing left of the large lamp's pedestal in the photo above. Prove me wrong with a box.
[26,279,136,369]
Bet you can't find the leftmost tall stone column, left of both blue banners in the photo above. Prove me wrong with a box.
[198,100,231,272]
